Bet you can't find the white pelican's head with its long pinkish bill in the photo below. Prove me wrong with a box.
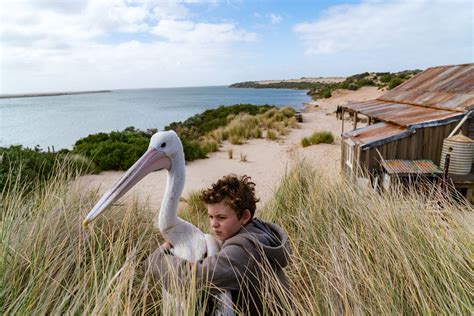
[83,131,184,226]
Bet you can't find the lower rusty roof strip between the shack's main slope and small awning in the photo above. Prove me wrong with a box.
[345,100,464,129]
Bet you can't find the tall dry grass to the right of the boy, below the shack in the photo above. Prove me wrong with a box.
[262,163,474,315]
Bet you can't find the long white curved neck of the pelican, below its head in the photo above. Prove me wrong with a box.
[158,152,186,233]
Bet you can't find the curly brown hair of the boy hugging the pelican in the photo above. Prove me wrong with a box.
[201,174,260,219]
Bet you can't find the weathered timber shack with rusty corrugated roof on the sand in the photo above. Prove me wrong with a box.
[341,64,474,200]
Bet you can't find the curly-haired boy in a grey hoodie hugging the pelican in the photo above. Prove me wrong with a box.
[146,174,289,315]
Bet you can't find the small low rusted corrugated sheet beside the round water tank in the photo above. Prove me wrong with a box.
[382,160,443,175]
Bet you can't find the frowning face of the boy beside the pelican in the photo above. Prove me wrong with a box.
[207,202,250,241]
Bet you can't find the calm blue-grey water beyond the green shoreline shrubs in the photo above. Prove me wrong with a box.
[0,86,310,150]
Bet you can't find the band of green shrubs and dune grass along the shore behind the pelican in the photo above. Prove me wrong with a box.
[0,104,298,191]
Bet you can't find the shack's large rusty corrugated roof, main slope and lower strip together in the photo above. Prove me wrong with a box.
[345,63,474,128]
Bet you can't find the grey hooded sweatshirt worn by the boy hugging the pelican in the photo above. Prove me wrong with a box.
[145,218,290,315]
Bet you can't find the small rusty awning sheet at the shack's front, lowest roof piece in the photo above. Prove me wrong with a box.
[342,122,415,150]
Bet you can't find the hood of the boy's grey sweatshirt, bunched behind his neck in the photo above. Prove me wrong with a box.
[231,218,290,268]
